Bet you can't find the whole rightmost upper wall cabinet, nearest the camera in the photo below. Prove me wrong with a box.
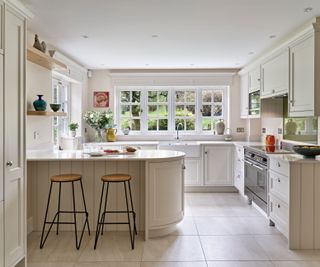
[289,29,320,117]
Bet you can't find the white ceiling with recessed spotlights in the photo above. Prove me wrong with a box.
[23,0,320,69]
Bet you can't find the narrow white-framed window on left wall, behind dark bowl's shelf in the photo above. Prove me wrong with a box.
[52,78,71,145]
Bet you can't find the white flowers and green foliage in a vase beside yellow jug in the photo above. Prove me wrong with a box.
[83,109,114,142]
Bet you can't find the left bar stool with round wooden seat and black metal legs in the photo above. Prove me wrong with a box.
[40,174,90,249]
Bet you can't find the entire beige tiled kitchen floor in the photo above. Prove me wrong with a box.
[28,193,320,267]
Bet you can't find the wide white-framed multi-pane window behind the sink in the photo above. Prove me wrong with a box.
[115,86,229,134]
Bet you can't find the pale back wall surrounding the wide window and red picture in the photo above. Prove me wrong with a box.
[87,70,246,140]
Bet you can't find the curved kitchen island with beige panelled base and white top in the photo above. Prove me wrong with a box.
[27,150,184,240]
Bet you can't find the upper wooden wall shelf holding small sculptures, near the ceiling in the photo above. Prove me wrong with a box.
[27,47,67,70]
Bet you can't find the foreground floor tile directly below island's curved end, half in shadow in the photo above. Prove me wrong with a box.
[142,236,205,261]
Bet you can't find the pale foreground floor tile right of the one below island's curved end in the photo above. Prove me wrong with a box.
[200,236,268,261]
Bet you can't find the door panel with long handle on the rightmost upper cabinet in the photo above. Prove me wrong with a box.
[289,36,314,116]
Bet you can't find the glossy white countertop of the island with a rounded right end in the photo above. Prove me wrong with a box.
[27,150,185,161]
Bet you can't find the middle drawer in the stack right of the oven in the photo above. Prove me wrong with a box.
[269,171,289,203]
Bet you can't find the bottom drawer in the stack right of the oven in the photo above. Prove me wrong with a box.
[270,194,289,238]
